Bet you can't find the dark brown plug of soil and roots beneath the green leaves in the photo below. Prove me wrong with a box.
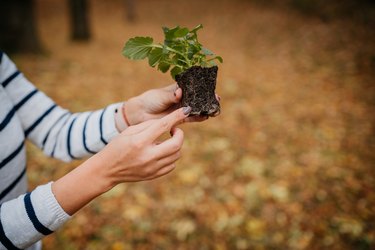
[176,66,220,116]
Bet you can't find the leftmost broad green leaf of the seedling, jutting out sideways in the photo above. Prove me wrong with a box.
[122,37,153,60]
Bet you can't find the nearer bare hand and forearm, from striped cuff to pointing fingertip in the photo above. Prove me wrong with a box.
[52,107,191,215]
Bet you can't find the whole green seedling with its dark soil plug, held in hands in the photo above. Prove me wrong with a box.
[122,24,223,116]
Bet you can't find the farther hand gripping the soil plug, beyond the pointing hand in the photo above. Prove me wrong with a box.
[123,84,220,125]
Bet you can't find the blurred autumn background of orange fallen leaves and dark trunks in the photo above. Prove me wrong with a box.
[0,0,375,250]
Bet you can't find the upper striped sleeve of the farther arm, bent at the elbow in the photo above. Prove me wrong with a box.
[0,54,120,161]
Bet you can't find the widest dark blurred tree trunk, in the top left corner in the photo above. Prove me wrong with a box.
[0,0,42,53]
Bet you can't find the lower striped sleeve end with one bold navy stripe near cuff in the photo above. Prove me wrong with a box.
[0,183,70,249]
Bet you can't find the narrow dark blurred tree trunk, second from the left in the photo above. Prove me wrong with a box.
[69,0,91,41]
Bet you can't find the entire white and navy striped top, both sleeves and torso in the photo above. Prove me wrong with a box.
[0,52,119,249]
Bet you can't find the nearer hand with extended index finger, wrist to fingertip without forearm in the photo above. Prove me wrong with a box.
[97,107,191,186]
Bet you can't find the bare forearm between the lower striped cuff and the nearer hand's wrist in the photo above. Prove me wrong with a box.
[52,153,113,215]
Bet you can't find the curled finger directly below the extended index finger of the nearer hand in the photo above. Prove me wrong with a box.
[153,128,184,159]
